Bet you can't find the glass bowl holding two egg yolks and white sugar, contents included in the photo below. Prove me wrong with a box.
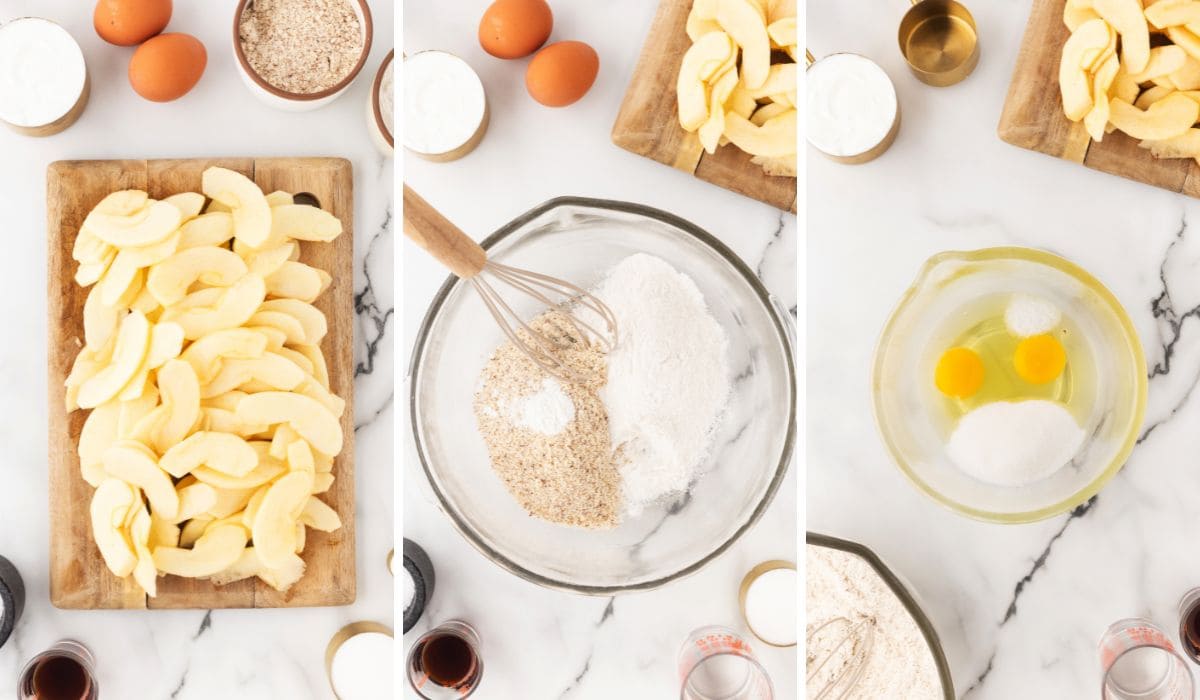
[871,247,1147,522]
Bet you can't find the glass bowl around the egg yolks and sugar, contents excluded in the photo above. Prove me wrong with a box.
[871,247,1147,522]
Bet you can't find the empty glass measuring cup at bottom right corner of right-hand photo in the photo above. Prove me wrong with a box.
[1100,617,1194,700]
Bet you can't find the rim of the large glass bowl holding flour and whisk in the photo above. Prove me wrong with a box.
[408,197,797,596]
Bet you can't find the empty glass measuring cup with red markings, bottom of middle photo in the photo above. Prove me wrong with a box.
[678,624,775,700]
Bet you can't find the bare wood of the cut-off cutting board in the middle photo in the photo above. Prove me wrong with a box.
[612,0,796,214]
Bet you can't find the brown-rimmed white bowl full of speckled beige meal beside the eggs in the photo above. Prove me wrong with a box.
[233,0,374,112]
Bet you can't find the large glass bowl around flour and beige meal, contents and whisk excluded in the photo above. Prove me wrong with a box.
[409,197,796,594]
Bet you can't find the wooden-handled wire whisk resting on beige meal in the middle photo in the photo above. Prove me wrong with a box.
[403,185,617,383]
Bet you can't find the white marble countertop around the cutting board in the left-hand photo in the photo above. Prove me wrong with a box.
[0,0,394,700]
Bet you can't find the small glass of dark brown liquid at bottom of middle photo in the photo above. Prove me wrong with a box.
[408,620,484,700]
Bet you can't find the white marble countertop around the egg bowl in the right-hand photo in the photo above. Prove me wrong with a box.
[806,0,1200,700]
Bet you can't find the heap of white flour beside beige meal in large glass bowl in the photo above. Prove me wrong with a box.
[593,253,730,515]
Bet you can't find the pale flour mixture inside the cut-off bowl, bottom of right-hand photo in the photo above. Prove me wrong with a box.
[804,545,942,700]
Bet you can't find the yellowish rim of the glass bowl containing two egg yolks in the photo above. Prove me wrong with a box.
[871,246,1148,523]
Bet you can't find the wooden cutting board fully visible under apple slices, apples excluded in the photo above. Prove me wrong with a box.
[46,158,355,610]
